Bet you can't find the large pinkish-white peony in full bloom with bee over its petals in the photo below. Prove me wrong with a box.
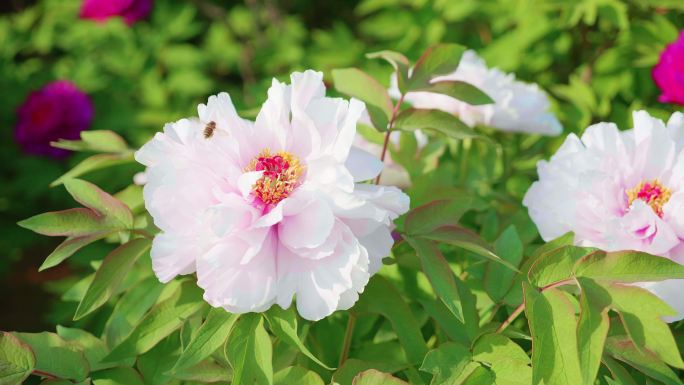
[136,71,409,320]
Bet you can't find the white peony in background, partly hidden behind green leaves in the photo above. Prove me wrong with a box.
[390,51,563,135]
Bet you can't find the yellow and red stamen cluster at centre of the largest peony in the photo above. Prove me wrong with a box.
[245,149,304,205]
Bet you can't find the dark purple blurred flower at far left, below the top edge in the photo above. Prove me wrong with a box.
[14,80,93,158]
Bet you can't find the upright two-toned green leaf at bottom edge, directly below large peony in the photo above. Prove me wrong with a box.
[226,313,273,385]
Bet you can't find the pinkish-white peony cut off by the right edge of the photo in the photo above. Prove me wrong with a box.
[523,111,684,320]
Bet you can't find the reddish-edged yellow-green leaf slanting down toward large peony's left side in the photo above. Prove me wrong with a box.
[64,179,133,229]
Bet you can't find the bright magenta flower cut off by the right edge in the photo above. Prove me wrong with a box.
[653,31,684,105]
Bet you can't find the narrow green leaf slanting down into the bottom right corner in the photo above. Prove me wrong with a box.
[606,337,682,385]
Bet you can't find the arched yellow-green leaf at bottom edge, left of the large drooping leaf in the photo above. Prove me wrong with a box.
[473,334,532,385]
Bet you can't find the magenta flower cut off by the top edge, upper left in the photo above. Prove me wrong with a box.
[81,0,152,25]
